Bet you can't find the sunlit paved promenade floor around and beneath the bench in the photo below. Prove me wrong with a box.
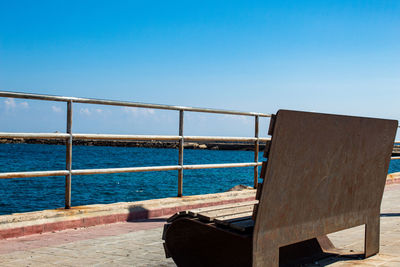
[0,184,400,267]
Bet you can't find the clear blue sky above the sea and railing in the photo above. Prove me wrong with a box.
[0,0,400,136]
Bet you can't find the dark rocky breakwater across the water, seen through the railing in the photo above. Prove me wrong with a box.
[0,138,266,151]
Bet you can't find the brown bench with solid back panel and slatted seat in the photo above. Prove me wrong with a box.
[163,110,398,266]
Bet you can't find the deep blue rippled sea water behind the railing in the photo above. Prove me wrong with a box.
[0,144,400,214]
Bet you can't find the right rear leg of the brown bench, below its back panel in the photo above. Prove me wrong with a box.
[364,217,380,258]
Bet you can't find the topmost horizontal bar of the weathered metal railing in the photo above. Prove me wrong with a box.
[0,91,271,117]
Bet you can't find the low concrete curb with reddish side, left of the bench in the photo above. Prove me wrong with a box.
[0,189,255,239]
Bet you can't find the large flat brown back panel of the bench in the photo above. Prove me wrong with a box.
[253,110,398,264]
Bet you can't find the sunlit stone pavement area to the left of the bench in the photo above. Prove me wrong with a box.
[0,218,175,266]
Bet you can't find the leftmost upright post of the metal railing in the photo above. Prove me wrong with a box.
[65,100,72,209]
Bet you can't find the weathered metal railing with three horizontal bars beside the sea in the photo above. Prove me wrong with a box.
[0,91,271,209]
